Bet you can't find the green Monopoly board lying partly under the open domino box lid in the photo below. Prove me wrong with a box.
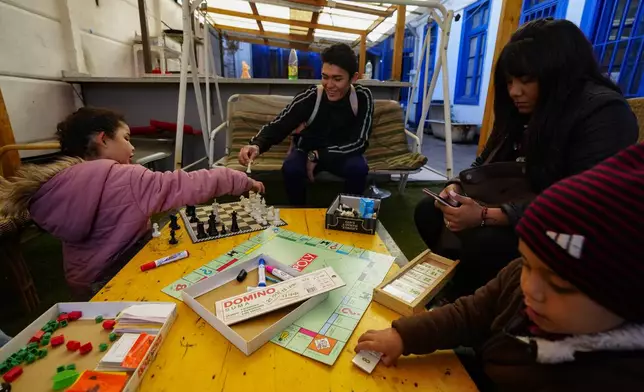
[163,227,394,365]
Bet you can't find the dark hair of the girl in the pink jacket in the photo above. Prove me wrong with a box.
[56,107,125,158]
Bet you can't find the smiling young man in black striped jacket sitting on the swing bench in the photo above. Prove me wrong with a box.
[239,44,373,205]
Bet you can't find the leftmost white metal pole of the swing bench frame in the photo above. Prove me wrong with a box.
[174,1,190,169]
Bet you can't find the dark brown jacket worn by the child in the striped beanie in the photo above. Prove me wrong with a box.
[393,260,644,392]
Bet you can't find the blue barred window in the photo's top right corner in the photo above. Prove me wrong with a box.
[590,0,644,98]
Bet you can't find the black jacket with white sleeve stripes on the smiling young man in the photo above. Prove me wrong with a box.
[250,84,374,164]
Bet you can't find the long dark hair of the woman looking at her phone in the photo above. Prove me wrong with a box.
[490,18,621,191]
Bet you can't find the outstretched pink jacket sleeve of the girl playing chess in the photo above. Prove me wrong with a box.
[130,166,253,215]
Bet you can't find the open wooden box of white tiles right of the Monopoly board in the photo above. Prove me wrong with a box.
[373,249,458,316]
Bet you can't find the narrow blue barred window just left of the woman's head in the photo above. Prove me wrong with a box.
[454,0,490,105]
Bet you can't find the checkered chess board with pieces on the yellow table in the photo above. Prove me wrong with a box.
[179,202,286,243]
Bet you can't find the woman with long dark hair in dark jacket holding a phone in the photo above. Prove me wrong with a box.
[414,19,638,296]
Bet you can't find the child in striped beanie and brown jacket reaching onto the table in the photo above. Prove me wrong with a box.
[356,144,644,391]
